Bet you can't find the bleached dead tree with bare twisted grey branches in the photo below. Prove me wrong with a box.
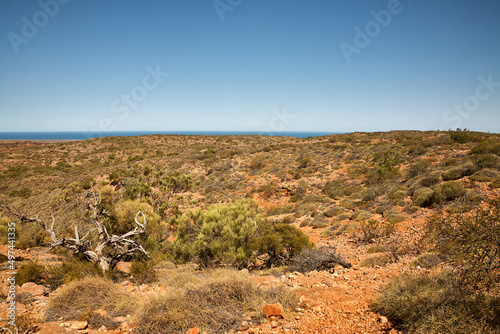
[2,190,149,271]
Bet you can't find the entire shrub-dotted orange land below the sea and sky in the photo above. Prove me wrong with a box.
[0,129,500,334]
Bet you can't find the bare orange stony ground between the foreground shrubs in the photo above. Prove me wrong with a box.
[0,224,421,334]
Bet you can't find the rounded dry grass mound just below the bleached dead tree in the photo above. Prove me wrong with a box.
[45,277,138,328]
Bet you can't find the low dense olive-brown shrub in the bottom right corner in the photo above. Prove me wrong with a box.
[373,273,500,334]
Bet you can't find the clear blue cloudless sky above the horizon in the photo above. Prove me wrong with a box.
[0,0,500,132]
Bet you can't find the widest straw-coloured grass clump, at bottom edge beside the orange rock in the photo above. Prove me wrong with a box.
[137,269,297,334]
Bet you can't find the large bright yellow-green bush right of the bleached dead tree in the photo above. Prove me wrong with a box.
[174,200,310,267]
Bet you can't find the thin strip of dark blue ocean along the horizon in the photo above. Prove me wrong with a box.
[0,131,342,140]
